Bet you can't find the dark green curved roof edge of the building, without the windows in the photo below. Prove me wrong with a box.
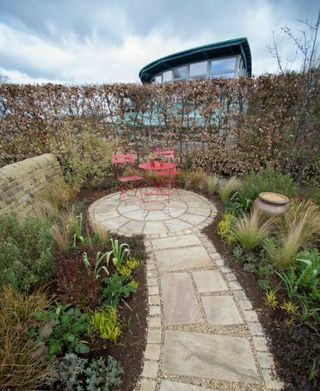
[139,38,252,83]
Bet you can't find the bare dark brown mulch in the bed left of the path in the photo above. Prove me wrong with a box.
[50,187,148,391]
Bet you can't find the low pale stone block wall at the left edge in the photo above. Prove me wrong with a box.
[0,153,63,214]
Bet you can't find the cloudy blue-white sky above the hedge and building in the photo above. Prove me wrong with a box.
[0,0,319,84]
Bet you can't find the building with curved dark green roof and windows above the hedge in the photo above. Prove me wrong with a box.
[139,38,252,84]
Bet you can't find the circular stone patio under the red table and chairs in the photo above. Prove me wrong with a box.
[89,188,216,237]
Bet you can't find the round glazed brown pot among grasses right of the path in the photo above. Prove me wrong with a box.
[252,192,290,219]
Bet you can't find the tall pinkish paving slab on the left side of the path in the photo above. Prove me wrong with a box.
[161,273,203,325]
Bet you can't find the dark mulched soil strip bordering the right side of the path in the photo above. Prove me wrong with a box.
[203,196,320,391]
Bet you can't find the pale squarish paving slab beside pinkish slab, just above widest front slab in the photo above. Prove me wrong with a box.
[202,296,243,325]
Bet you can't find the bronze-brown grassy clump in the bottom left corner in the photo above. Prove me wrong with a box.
[0,287,51,390]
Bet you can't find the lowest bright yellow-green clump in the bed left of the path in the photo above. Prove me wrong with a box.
[89,307,121,343]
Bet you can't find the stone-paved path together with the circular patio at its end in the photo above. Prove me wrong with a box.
[90,190,281,391]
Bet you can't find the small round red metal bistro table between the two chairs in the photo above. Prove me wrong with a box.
[138,162,176,196]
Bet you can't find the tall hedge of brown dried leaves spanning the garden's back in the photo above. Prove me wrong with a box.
[0,73,320,181]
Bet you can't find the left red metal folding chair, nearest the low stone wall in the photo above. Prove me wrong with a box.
[112,153,143,203]
